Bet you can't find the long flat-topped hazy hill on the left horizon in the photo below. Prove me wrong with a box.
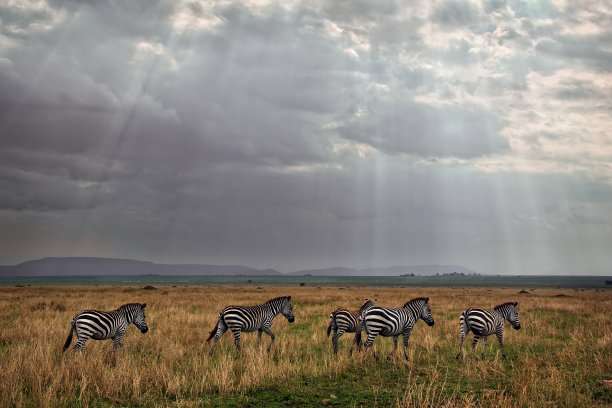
[0,258,280,276]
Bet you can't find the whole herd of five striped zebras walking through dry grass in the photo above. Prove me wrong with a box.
[63,296,521,359]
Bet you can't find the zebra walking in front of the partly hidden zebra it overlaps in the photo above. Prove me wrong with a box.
[362,297,435,360]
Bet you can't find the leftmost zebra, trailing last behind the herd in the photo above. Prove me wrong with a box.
[62,303,149,356]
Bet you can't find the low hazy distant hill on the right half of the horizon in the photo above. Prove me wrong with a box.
[287,265,476,276]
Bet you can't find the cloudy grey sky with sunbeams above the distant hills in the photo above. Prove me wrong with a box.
[0,0,612,275]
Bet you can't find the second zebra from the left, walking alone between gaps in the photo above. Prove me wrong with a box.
[206,296,295,356]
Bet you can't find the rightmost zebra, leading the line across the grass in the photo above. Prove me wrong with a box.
[455,302,521,359]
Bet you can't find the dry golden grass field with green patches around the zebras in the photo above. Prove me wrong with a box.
[0,285,612,407]
